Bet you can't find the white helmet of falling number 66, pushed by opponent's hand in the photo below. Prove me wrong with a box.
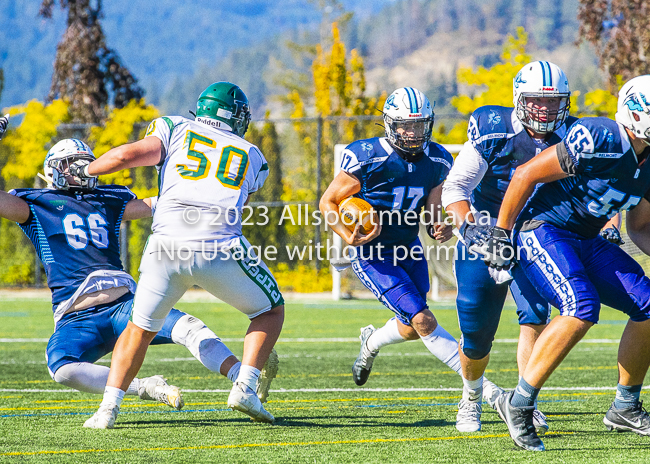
[43,139,97,190]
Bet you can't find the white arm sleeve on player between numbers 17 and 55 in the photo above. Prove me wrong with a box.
[442,142,488,208]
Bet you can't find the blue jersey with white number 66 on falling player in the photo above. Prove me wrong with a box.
[9,185,136,306]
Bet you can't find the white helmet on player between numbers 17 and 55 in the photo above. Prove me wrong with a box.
[512,61,571,134]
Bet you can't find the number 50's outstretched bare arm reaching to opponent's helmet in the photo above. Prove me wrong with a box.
[87,137,162,176]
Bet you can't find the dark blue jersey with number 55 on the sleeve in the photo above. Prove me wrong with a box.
[518,118,650,238]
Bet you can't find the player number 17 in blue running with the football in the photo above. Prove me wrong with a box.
[320,87,497,406]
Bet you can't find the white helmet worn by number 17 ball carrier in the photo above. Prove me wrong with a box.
[383,87,434,154]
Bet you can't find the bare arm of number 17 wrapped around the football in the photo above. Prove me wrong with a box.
[318,171,381,246]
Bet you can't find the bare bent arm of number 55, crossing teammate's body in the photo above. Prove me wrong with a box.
[497,145,569,230]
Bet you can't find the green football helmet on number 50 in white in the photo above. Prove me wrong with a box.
[196,82,251,137]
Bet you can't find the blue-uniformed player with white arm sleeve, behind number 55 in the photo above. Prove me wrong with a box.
[442,61,575,433]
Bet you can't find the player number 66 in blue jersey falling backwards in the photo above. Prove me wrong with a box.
[0,139,275,409]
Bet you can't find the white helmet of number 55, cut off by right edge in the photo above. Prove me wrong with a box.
[616,74,650,139]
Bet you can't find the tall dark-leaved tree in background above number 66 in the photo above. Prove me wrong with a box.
[40,0,144,123]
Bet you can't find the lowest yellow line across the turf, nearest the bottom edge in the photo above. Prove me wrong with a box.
[0,432,540,456]
